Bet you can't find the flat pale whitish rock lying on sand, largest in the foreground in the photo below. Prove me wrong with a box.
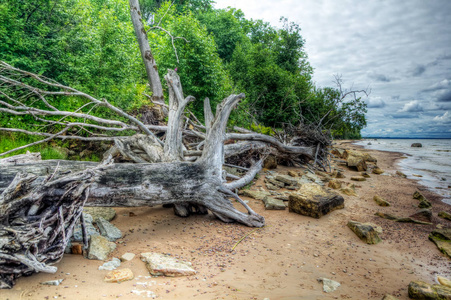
[141,252,196,277]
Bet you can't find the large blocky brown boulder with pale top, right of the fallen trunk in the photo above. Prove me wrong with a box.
[288,183,344,218]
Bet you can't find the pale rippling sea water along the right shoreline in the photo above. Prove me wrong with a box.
[355,138,451,205]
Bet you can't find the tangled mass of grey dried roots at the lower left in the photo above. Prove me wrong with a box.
[0,164,112,288]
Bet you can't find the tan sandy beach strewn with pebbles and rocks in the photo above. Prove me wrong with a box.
[0,142,451,300]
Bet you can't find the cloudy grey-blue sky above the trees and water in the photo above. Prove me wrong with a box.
[215,0,451,138]
